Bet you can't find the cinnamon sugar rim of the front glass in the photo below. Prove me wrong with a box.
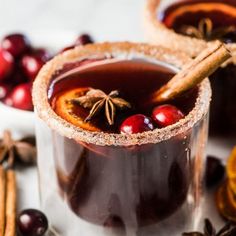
[33,42,211,146]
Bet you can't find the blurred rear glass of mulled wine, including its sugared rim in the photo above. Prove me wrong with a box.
[144,0,236,137]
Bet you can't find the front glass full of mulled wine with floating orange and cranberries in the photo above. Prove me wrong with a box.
[34,44,210,236]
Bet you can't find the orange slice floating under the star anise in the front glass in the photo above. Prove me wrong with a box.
[52,88,100,131]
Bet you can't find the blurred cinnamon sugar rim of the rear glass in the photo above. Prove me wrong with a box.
[144,0,236,66]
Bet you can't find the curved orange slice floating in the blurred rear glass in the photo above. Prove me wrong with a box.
[165,2,236,27]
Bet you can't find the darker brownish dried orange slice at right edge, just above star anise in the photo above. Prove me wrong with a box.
[216,181,236,222]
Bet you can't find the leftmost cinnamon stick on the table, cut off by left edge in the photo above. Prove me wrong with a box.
[0,166,6,236]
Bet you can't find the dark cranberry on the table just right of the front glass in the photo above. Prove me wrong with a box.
[206,156,225,187]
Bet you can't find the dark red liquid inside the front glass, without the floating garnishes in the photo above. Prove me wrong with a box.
[50,60,197,232]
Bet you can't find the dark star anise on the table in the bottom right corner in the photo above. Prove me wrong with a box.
[182,219,236,236]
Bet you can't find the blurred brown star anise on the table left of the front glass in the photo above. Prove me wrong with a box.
[0,130,36,167]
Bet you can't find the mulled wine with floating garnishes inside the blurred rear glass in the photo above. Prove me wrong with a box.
[158,0,236,134]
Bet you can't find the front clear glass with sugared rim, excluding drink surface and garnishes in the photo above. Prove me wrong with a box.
[33,42,211,236]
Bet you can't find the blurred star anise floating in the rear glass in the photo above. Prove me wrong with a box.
[179,18,236,41]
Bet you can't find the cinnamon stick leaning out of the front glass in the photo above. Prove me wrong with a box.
[148,41,231,104]
